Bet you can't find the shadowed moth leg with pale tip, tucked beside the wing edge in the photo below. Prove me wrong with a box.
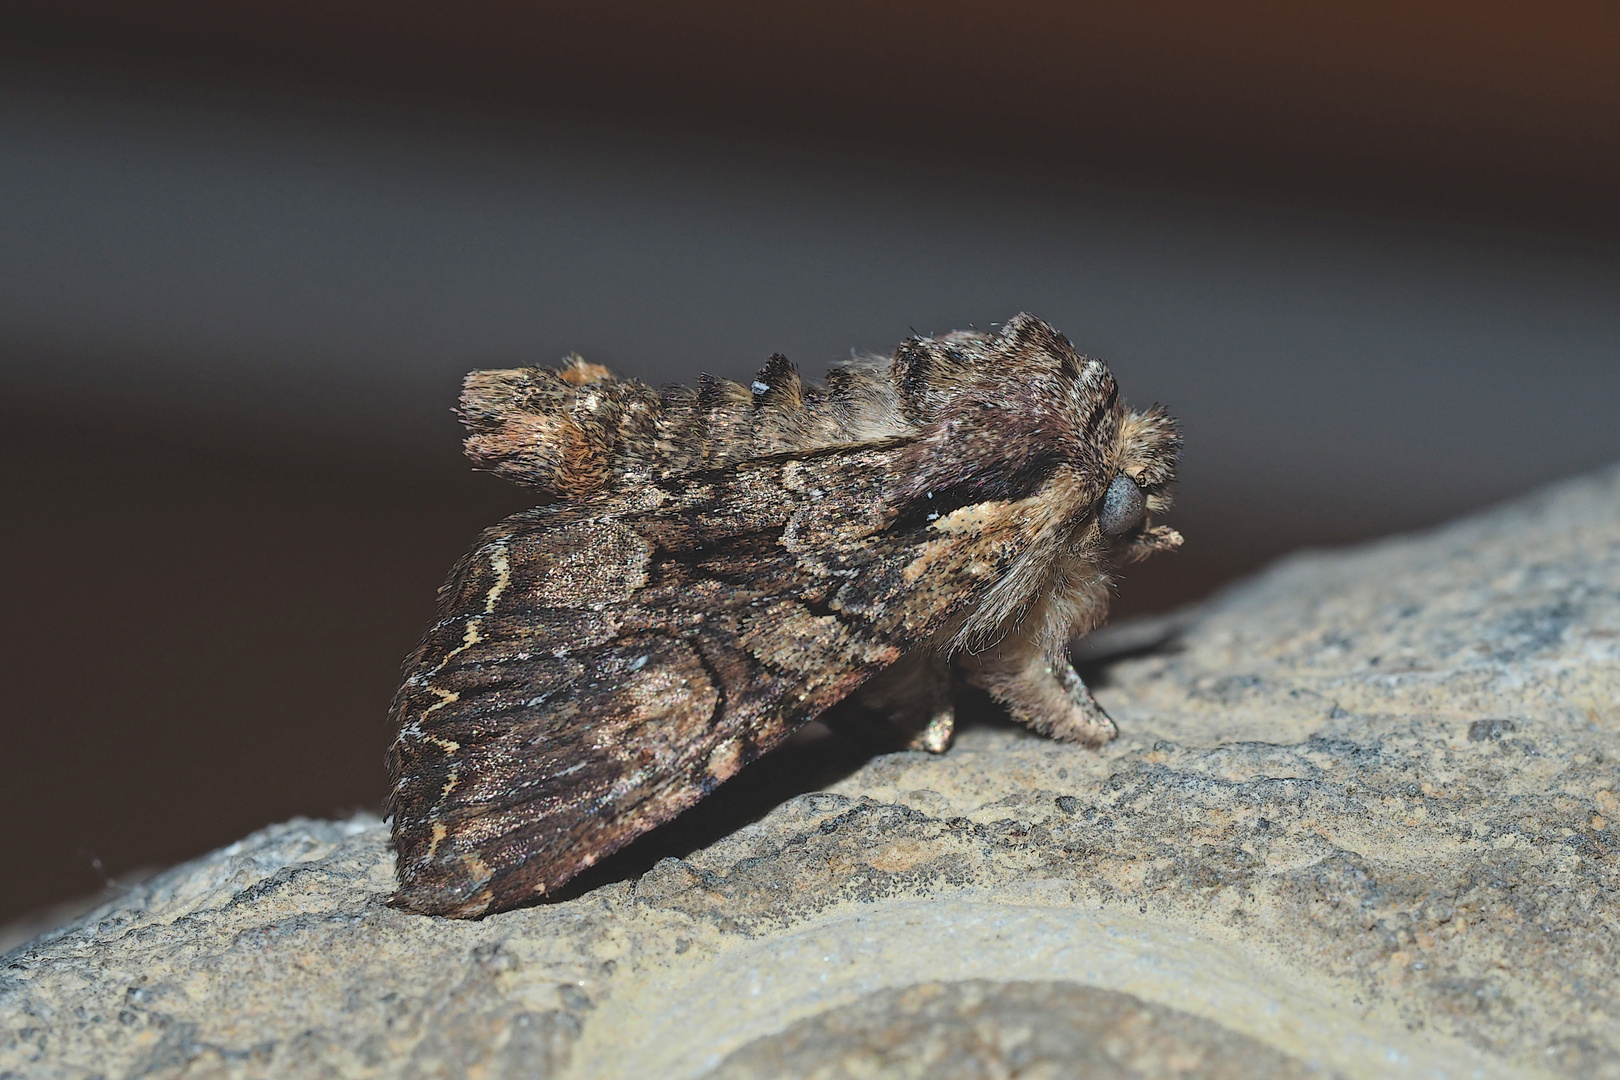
[820,651,956,753]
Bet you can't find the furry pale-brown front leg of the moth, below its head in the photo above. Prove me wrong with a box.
[962,638,1119,746]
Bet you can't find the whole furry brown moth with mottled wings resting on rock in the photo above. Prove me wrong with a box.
[387,314,1181,918]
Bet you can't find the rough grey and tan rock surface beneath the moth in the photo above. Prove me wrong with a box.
[9,471,1620,1077]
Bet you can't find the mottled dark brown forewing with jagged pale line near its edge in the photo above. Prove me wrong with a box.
[389,444,1017,916]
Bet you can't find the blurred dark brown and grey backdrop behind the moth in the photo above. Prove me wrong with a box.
[0,0,1620,920]
